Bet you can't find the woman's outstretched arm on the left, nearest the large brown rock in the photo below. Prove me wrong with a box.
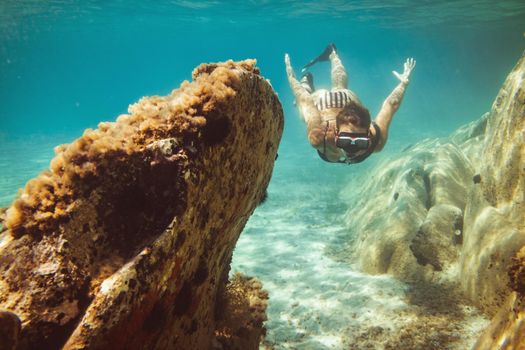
[284,54,324,148]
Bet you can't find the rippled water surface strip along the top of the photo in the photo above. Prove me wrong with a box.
[0,0,525,27]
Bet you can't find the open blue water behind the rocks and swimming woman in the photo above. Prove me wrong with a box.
[0,0,525,206]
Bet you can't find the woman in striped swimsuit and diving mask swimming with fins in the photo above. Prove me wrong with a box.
[284,44,416,164]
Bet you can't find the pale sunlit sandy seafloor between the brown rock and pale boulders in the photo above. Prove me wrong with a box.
[232,154,488,349]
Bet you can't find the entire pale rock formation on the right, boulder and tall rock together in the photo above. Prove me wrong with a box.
[346,51,525,349]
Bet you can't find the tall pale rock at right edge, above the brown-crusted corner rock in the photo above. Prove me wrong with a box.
[460,55,525,314]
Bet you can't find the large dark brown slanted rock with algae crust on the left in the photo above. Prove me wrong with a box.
[0,60,284,349]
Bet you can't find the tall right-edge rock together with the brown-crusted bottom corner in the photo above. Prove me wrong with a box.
[461,54,525,349]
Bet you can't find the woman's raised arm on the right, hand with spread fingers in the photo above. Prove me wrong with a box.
[374,58,416,152]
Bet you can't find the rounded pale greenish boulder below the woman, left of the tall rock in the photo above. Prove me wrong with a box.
[345,139,474,282]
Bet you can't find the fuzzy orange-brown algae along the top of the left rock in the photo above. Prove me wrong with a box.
[5,60,256,237]
